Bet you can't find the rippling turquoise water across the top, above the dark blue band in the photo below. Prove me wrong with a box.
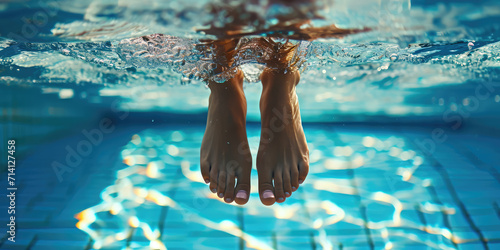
[0,0,500,122]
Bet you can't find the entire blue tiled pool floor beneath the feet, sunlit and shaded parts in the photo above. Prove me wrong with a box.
[2,125,500,249]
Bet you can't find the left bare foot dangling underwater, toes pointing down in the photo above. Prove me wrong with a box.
[200,71,252,205]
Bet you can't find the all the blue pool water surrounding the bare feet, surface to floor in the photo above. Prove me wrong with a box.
[0,0,500,249]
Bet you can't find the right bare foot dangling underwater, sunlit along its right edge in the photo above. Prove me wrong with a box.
[257,68,309,205]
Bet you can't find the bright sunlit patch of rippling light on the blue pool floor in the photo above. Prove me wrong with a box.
[76,129,484,249]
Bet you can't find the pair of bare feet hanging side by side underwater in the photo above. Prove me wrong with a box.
[200,68,309,206]
